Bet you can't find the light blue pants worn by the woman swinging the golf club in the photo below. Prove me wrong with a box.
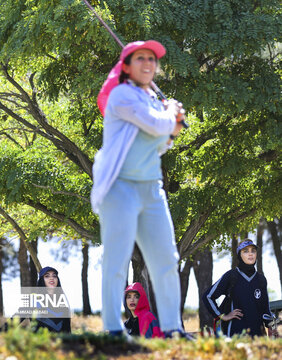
[99,179,182,331]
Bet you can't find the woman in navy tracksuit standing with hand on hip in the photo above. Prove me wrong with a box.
[202,239,276,336]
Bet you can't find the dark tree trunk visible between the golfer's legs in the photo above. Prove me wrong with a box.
[131,244,158,317]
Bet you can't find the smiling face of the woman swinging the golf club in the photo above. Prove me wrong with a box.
[122,49,157,89]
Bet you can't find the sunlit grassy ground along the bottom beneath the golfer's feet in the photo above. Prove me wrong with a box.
[0,314,282,360]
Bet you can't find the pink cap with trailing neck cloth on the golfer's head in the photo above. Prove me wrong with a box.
[97,40,166,116]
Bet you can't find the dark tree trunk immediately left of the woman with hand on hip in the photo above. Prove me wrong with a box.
[193,248,213,329]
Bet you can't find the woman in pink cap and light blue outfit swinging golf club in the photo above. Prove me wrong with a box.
[91,40,189,337]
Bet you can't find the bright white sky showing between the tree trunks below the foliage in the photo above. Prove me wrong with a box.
[3,232,281,317]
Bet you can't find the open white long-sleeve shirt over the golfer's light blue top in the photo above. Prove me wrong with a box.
[91,83,176,213]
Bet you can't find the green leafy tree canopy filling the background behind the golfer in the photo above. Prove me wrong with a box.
[0,0,282,256]
